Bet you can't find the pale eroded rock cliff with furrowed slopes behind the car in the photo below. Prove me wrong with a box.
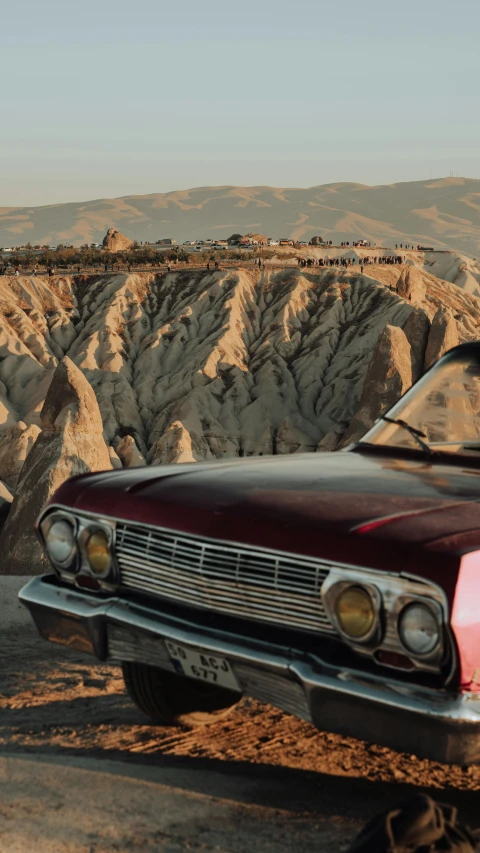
[0,266,480,470]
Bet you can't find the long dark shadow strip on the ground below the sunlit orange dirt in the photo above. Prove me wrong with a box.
[5,745,480,828]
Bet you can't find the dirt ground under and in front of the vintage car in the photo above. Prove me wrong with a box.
[0,627,480,853]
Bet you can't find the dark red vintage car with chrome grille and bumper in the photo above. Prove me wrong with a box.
[20,342,480,764]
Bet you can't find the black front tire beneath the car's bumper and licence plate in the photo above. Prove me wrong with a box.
[122,662,241,728]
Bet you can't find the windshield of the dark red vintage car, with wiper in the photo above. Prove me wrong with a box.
[361,344,480,455]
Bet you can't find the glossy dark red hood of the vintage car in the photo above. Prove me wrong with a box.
[53,449,480,584]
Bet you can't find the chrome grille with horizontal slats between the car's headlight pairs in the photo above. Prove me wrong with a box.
[116,523,334,633]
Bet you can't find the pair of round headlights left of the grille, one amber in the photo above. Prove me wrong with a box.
[39,510,116,589]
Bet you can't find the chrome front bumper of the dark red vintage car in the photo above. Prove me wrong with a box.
[19,575,480,764]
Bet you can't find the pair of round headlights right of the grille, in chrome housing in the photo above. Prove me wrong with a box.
[324,573,443,668]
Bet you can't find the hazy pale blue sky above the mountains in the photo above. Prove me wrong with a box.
[0,0,480,206]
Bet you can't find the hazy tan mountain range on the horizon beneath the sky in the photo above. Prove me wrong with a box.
[0,178,480,251]
